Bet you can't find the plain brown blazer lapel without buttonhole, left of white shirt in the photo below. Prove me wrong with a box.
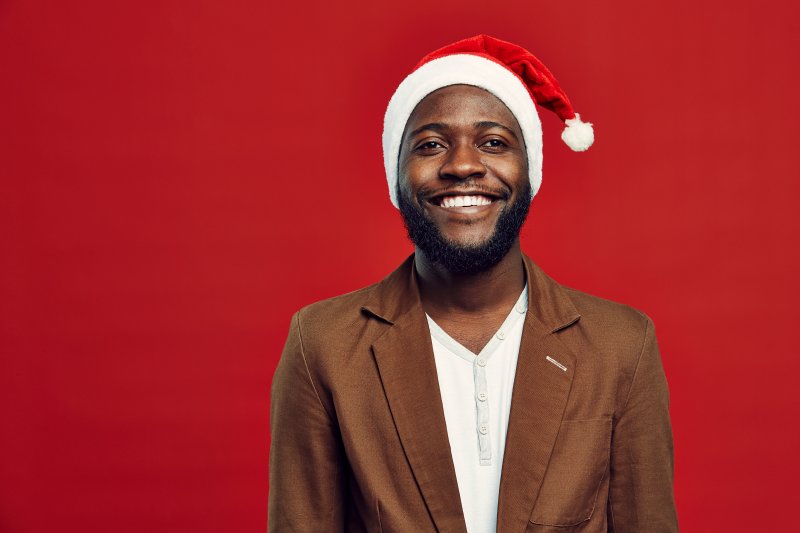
[364,261,467,533]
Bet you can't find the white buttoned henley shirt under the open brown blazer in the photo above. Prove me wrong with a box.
[426,285,528,533]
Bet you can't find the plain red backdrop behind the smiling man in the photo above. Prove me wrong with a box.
[0,0,800,533]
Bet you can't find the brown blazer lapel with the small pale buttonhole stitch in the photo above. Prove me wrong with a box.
[497,257,580,532]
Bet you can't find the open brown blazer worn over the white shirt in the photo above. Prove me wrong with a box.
[269,256,678,533]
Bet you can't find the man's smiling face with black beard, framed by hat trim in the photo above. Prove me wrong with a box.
[397,85,531,273]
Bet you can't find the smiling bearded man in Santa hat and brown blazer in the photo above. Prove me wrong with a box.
[269,36,677,533]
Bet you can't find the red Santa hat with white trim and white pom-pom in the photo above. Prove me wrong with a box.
[383,35,594,207]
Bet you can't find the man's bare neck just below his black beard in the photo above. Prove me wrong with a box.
[414,240,525,319]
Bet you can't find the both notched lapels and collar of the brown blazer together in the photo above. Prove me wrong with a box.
[362,255,580,533]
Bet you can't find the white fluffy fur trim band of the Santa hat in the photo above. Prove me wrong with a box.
[383,54,542,207]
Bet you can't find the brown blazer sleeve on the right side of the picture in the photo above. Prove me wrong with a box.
[608,318,678,533]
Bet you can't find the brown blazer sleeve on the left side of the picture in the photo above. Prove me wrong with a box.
[268,312,345,532]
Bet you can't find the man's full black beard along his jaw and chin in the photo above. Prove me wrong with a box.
[397,182,532,274]
